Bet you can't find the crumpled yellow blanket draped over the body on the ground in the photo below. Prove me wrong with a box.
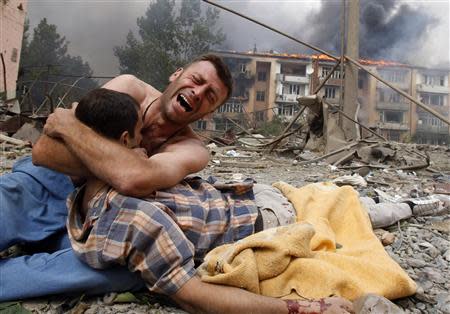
[199,182,416,300]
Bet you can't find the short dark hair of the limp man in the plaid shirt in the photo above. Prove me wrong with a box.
[75,88,139,140]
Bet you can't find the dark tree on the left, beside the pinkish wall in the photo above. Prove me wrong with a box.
[19,18,97,113]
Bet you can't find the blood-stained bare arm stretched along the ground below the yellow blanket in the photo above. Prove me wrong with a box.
[172,277,353,314]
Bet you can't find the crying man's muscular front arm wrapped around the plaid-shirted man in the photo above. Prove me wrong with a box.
[44,109,209,197]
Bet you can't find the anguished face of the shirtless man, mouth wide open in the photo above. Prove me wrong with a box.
[161,61,228,124]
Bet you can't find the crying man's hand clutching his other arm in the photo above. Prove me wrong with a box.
[44,106,78,138]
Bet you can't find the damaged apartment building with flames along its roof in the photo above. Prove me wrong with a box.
[196,51,450,145]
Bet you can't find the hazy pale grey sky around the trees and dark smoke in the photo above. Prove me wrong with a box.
[28,0,450,75]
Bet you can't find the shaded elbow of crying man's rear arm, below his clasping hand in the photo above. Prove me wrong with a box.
[32,134,90,177]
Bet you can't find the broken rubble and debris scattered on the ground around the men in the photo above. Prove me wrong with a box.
[0,121,450,313]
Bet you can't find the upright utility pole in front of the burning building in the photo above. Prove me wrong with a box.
[341,0,359,140]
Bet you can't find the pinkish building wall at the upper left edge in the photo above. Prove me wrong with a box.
[0,0,27,99]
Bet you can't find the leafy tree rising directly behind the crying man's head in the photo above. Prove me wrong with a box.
[114,0,225,90]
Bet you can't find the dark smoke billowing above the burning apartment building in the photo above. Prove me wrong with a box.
[296,0,438,61]
